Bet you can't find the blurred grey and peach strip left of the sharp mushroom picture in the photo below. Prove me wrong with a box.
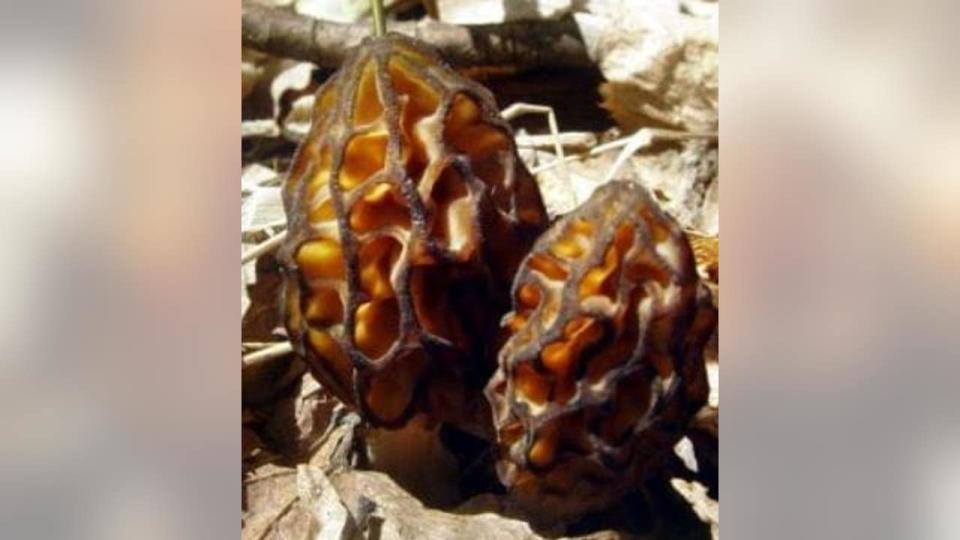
[0,0,240,539]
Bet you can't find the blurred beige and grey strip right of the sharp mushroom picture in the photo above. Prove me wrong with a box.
[720,0,960,539]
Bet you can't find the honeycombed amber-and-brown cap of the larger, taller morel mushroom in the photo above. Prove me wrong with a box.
[280,34,547,431]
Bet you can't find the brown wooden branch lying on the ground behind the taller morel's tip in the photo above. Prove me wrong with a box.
[242,1,593,69]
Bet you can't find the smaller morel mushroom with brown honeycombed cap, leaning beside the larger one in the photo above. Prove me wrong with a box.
[486,182,716,519]
